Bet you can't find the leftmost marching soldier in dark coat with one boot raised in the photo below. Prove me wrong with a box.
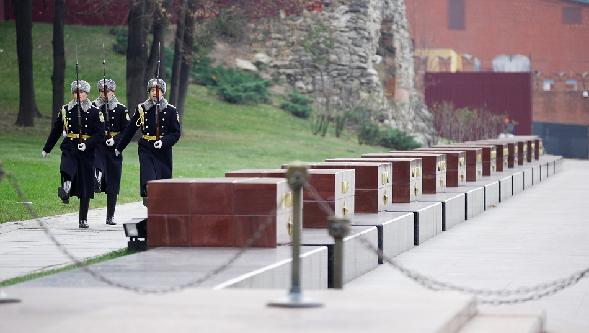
[42,80,104,229]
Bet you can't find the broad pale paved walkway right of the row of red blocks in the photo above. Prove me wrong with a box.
[347,160,589,332]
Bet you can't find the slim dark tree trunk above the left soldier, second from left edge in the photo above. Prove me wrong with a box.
[51,0,65,119]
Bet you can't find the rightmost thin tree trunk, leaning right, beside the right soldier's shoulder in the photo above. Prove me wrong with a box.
[176,0,198,117]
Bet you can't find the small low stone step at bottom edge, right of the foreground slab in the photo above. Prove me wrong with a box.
[458,314,544,333]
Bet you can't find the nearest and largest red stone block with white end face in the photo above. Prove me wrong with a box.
[147,177,292,247]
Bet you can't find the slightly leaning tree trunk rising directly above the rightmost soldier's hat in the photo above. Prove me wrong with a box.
[145,0,172,81]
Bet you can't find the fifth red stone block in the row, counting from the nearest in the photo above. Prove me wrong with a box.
[362,151,446,194]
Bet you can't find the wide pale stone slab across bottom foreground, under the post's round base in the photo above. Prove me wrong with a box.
[0,288,476,333]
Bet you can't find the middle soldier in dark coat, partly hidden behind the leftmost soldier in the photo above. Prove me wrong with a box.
[93,79,130,225]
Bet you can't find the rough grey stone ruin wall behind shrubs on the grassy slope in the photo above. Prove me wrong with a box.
[227,0,434,144]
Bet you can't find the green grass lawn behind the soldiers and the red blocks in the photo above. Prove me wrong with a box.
[0,22,384,223]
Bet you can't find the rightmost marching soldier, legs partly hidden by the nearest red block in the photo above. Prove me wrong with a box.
[115,79,180,205]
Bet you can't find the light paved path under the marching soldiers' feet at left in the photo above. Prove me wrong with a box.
[0,202,147,281]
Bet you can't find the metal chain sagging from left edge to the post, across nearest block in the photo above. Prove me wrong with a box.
[0,171,284,294]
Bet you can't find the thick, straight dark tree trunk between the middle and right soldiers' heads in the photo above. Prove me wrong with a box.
[127,0,147,108]
